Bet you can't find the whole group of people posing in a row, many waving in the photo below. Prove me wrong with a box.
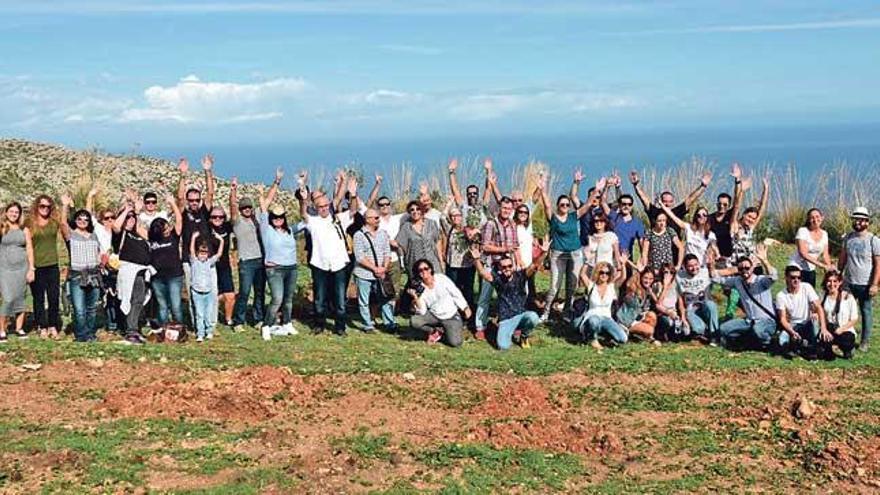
[0,156,880,359]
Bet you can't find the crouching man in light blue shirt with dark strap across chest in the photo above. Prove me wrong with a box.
[709,243,778,349]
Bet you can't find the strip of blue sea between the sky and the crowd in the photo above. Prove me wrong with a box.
[132,124,880,191]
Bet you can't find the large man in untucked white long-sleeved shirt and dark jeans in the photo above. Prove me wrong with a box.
[300,175,350,337]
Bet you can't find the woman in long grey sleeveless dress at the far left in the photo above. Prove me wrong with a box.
[0,202,32,342]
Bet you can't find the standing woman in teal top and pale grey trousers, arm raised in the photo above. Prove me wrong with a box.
[537,173,592,322]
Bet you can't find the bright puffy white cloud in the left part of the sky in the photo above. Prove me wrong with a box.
[120,75,307,122]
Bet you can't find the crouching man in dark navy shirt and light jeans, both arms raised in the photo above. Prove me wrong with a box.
[470,246,547,351]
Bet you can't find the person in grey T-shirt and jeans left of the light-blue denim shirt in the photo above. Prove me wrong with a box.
[229,174,266,328]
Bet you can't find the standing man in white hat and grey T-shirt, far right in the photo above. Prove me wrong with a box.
[837,206,880,352]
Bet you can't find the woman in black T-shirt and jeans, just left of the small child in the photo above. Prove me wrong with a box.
[147,194,184,325]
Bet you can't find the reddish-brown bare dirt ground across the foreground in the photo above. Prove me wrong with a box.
[0,360,880,493]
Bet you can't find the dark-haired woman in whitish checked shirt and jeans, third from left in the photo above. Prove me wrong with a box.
[62,203,101,342]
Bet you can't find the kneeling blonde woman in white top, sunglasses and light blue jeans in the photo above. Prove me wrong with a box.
[573,257,627,350]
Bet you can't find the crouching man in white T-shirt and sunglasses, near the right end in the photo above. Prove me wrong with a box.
[776,265,827,360]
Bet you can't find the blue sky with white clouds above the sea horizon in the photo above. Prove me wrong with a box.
[0,0,880,148]
